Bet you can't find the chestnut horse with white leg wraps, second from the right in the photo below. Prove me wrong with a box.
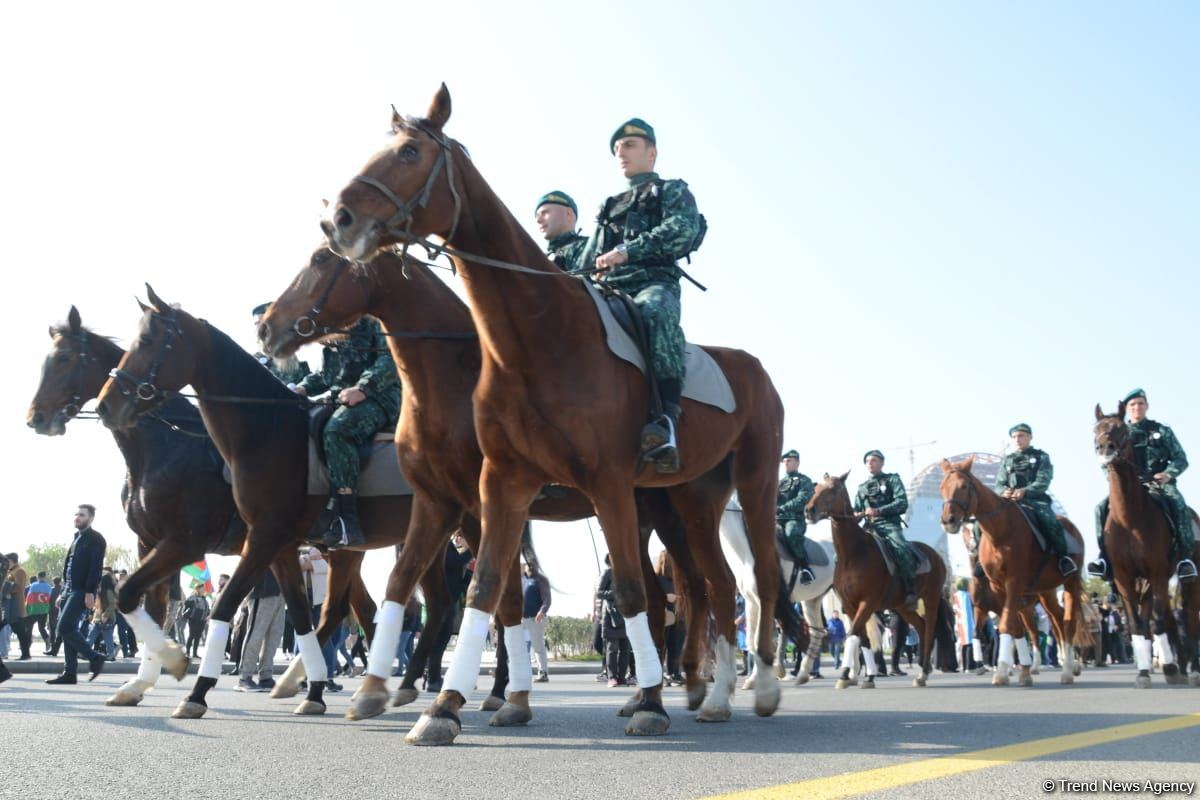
[941,456,1086,686]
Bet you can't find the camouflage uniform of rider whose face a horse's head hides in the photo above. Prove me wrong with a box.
[300,317,400,491]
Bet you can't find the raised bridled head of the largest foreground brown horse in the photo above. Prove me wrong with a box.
[320,84,461,261]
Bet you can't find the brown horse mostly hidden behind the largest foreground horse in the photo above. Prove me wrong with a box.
[259,247,753,724]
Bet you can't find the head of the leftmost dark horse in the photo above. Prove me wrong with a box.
[25,306,119,437]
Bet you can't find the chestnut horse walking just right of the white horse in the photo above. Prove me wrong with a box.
[804,473,946,688]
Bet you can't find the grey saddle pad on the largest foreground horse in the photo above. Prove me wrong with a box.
[583,281,738,414]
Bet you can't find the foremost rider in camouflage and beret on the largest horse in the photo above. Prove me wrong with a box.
[576,118,706,474]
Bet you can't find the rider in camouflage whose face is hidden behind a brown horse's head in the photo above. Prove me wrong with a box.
[295,317,400,548]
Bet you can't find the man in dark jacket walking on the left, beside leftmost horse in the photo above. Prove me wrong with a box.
[46,504,107,684]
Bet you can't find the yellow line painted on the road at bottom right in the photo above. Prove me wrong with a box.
[710,714,1200,800]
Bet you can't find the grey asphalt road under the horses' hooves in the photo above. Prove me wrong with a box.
[0,667,1200,800]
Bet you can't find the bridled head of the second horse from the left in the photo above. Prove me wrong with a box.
[96,283,203,431]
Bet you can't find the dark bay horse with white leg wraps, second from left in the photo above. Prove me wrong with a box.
[96,287,427,718]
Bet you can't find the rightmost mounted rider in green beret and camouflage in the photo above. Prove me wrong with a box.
[1087,389,1196,581]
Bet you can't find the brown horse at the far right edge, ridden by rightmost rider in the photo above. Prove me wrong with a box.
[1093,401,1200,688]
